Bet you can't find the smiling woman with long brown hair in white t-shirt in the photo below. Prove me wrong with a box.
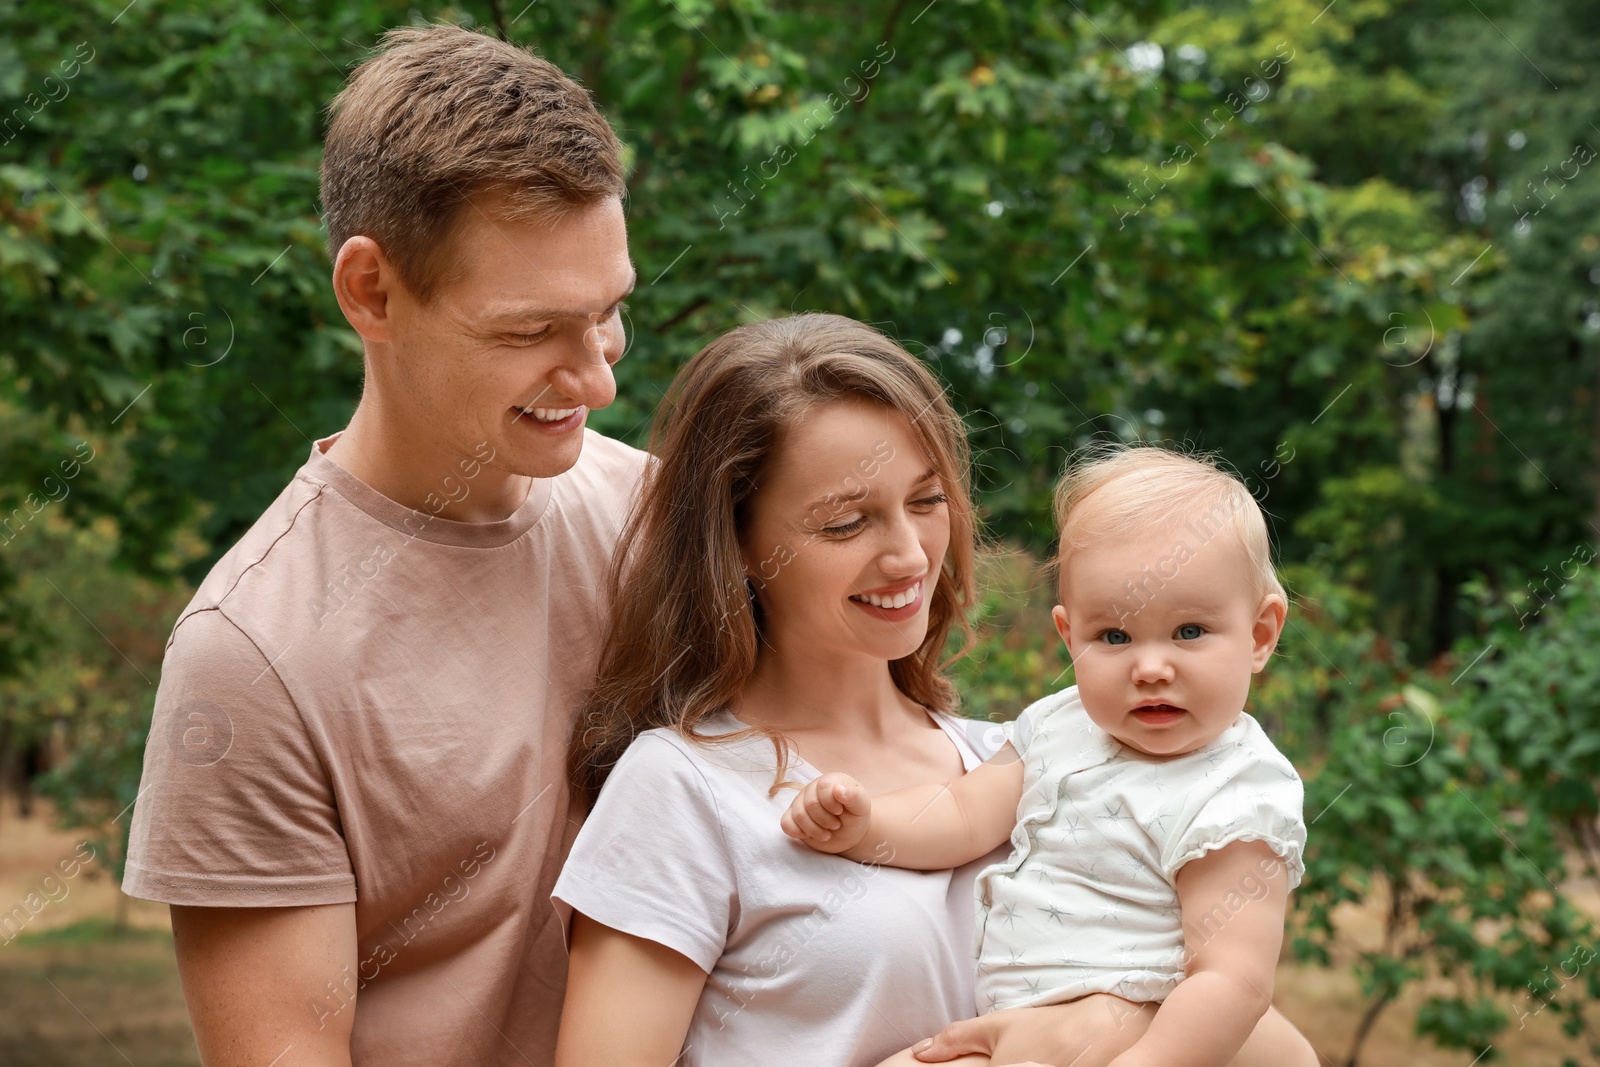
[554,315,1305,1067]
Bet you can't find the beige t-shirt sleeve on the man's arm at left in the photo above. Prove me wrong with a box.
[122,609,355,907]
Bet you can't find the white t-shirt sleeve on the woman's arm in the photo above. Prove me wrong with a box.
[550,734,739,974]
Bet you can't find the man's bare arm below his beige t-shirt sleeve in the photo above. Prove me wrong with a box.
[171,904,358,1067]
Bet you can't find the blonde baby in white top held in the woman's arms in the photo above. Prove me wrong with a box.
[782,446,1309,1067]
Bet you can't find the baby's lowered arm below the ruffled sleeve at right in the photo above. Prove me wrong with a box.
[1112,841,1290,1067]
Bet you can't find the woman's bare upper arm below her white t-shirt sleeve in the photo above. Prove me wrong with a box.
[555,913,706,1067]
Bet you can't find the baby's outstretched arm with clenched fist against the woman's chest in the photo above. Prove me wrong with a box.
[782,744,1022,870]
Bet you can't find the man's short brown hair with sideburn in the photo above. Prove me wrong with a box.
[322,26,624,302]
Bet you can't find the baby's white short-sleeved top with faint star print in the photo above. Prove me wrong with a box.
[978,686,1306,1013]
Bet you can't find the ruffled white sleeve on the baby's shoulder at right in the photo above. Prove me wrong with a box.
[1162,747,1306,889]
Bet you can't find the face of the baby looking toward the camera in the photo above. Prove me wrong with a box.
[1053,525,1285,758]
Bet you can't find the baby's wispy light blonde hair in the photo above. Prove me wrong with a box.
[1054,445,1288,601]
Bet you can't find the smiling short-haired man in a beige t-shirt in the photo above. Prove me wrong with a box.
[123,27,645,1067]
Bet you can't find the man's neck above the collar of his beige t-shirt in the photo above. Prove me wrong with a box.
[323,395,533,523]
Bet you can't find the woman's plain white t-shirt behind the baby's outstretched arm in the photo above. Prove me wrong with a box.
[550,713,1003,1067]
